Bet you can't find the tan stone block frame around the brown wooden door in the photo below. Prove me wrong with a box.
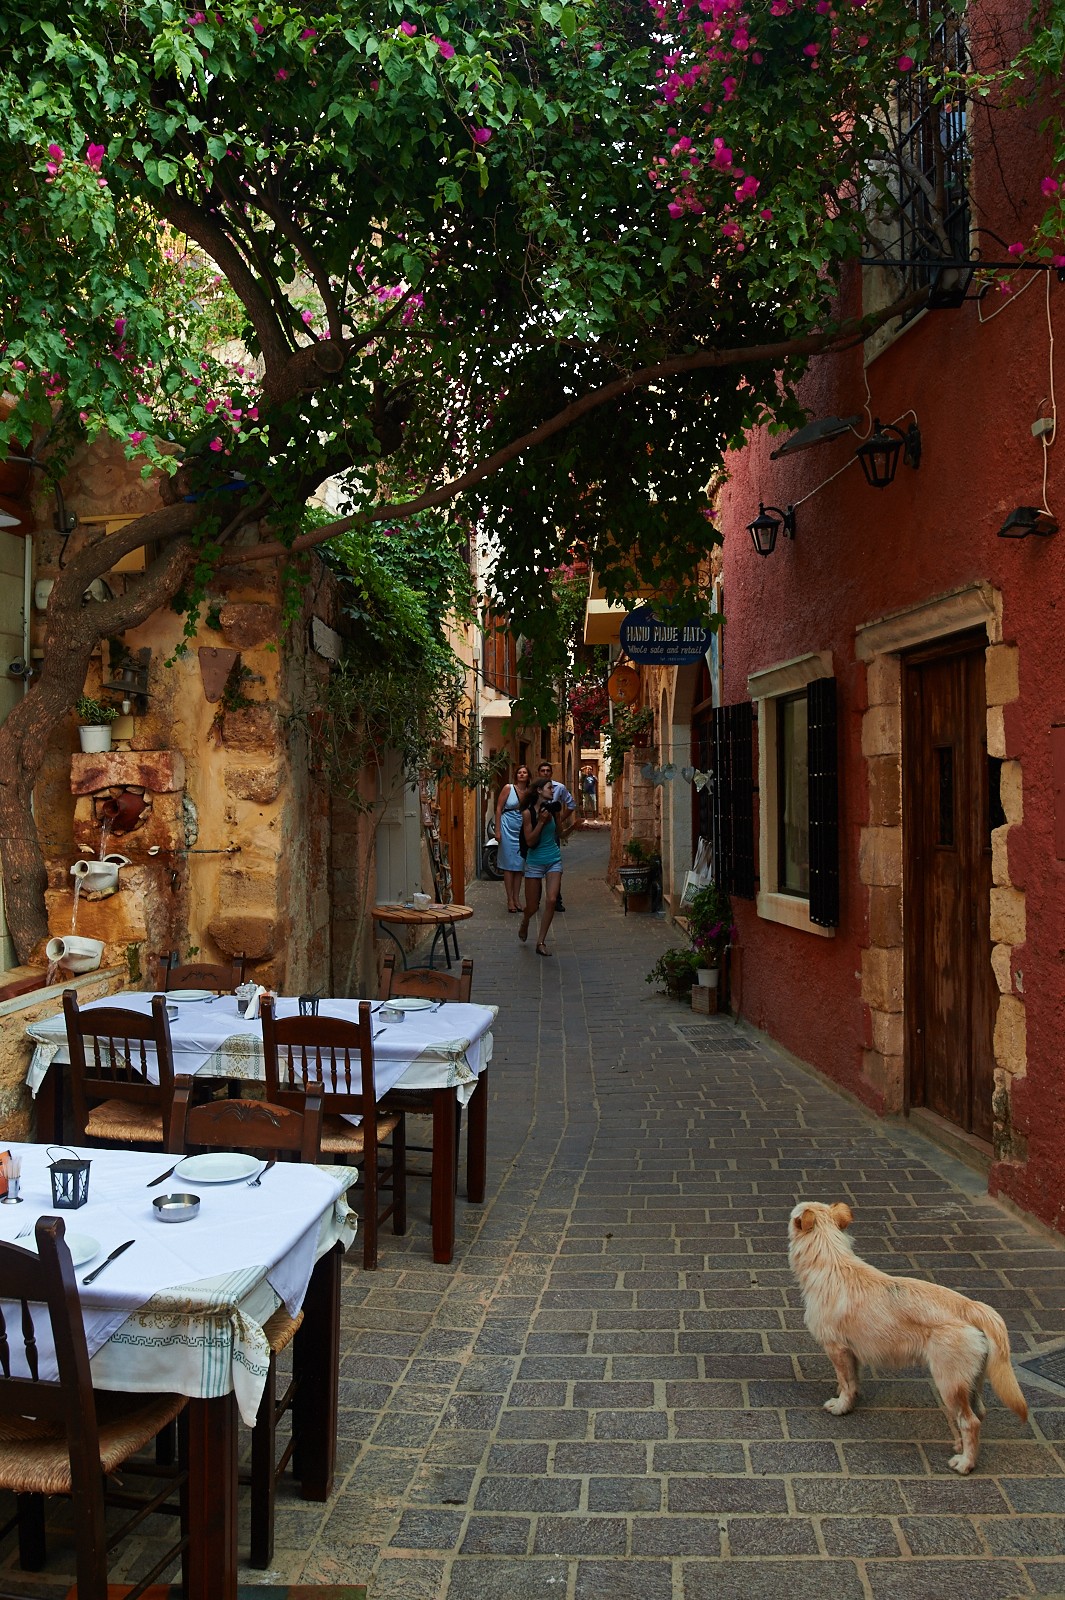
[854,582,1027,1162]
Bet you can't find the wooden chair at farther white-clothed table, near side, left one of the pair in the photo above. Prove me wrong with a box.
[62,989,174,1146]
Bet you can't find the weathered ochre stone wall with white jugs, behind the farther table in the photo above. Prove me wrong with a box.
[35,428,336,990]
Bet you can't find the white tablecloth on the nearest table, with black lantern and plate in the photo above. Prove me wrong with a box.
[0,1144,355,1424]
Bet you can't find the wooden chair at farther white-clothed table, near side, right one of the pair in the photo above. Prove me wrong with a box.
[261,995,406,1272]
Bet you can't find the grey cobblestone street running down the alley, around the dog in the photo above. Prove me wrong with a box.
[271,832,1065,1600]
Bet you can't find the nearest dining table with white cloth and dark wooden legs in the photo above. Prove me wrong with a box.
[0,1144,355,1600]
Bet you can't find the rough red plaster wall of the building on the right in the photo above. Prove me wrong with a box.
[720,139,1065,1227]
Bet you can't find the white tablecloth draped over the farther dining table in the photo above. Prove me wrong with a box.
[26,990,497,1106]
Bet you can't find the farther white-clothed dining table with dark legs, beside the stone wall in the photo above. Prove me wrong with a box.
[26,990,497,1262]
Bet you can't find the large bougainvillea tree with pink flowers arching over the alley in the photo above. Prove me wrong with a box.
[0,0,1062,958]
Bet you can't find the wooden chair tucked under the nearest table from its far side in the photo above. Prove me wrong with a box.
[170,1075,321,1568]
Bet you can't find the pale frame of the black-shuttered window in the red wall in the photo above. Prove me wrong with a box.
[747,650,836,939]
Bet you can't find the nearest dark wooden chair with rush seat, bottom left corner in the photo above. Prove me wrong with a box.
[0,1216,189,1600]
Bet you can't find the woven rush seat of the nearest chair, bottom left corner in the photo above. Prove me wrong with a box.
[0,1390,185,1494]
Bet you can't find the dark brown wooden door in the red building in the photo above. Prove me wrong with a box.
[902,635,996,1141]
